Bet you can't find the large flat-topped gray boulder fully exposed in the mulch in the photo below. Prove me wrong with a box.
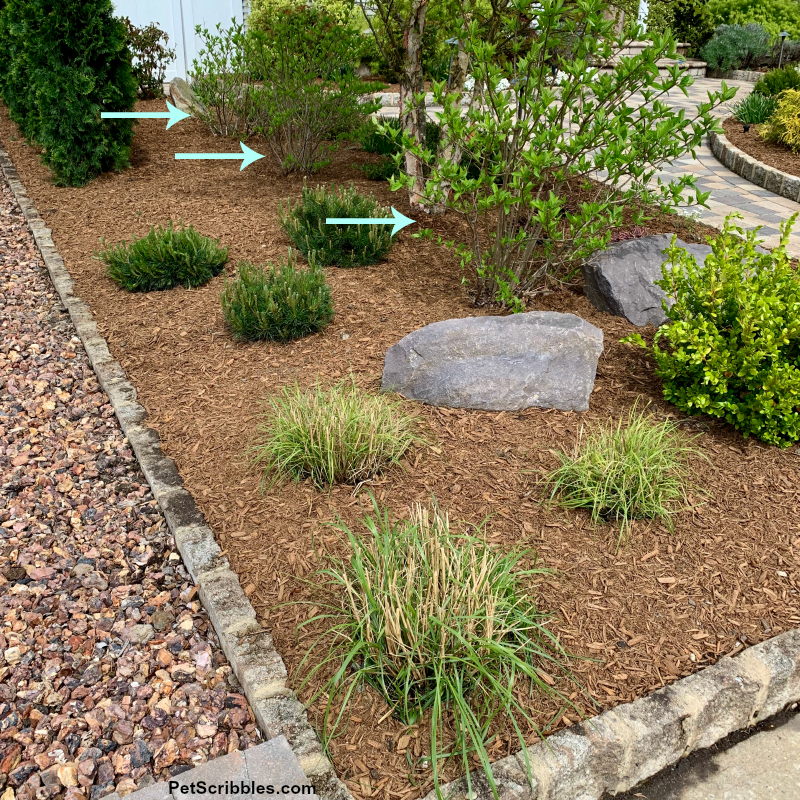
[381,311,603,411]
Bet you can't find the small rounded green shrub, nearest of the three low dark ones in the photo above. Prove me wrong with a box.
[221,250,333,342]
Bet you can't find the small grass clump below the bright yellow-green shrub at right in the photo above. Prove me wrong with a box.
[546,406,697,540]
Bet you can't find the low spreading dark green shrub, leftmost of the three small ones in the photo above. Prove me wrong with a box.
[99,221,228,292]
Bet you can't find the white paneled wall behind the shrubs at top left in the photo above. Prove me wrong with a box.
[114,0,249,81]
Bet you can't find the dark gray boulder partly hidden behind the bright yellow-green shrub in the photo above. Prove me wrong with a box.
[583,233,711,327]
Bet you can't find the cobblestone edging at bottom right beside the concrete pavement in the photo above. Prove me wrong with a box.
[425,629,800,800]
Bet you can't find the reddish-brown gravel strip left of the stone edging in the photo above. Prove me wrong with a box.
[0,181,260,800]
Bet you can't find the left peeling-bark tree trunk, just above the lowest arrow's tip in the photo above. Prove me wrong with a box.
[400,0,428,208]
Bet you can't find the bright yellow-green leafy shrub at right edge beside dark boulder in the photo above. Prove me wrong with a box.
[634,214,800,447]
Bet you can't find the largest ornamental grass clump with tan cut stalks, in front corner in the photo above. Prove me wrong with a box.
[301,498,571,796]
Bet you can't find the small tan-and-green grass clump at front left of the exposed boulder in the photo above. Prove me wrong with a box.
[252,380,419,486]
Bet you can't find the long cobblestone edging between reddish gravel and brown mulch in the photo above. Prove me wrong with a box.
[0,149,352,800]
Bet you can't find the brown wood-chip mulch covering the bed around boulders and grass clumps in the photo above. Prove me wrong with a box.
[0,104,800,800]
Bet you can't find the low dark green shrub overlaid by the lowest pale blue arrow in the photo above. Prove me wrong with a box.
[279,186,392,267]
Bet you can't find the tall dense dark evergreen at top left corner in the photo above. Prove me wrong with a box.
[0,0,136,186]
